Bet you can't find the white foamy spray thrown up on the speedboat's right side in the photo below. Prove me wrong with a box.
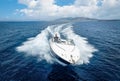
[62,25,97,64]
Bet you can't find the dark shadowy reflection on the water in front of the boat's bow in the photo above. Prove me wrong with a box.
[48,65,80,81]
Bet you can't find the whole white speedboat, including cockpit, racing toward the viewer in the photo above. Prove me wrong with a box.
[49,34,80,64]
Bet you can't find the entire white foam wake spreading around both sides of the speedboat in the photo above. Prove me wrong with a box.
[16,24,97,64]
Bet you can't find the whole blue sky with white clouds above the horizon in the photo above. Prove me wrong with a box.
[0,0,120,21]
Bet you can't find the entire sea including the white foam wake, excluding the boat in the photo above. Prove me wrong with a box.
[0,20,120,81]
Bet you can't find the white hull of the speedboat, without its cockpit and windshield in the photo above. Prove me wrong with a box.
[50,39,80,64]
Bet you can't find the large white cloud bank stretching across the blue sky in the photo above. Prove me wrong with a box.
[18,0,120,20]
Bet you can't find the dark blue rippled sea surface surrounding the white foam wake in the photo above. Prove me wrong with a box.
[0,21,120,81]
